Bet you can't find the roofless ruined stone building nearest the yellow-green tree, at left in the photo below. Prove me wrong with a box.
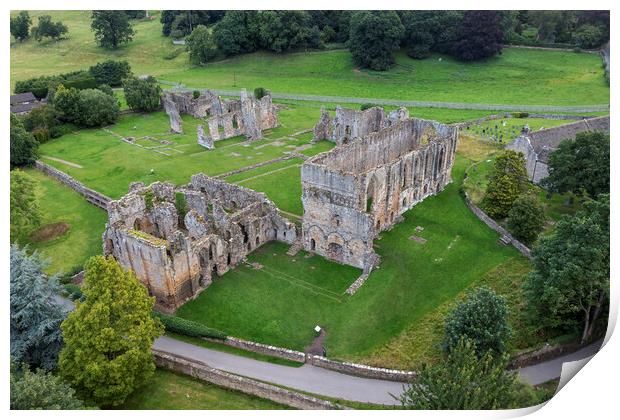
[103,174,297,312]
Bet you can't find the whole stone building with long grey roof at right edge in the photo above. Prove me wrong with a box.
[506,115,609,184]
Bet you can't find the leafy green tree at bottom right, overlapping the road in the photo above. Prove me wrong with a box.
[398,339,517,410]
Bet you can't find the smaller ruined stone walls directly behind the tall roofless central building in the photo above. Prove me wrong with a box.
[313,106,409,145]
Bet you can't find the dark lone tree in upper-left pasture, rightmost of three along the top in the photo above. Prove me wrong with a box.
[90,10,136,49]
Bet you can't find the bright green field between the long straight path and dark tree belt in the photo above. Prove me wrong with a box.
[161,48,609,105]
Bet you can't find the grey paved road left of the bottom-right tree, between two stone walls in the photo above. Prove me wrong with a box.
[153,336,403,405]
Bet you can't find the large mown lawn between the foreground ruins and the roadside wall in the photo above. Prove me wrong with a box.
[177,156,518,365]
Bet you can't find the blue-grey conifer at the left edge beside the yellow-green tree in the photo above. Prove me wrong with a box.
[11,245,65,369]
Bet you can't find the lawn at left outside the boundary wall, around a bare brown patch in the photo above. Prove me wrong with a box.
[20,169,107,274]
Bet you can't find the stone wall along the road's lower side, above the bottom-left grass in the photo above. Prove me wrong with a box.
[153,350,344,410]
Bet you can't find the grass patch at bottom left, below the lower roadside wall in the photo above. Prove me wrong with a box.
[119,369,288,410]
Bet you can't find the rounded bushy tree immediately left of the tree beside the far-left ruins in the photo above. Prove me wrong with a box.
[75,89,120,127]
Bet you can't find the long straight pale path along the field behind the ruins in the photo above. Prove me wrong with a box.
[158,80,609,113]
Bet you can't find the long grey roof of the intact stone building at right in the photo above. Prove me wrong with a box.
[528,115,609,163]
